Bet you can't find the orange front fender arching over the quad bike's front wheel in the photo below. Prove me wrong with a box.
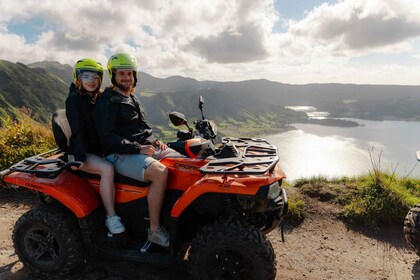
[171,175,264,219]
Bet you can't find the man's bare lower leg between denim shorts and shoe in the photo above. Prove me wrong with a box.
[144,161,168,232]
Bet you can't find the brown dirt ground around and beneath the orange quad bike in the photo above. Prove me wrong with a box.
[0,189,420,280]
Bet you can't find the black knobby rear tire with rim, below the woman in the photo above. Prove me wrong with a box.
[13,204,84,279]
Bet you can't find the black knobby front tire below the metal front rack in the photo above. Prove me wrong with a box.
[189,218,276,280]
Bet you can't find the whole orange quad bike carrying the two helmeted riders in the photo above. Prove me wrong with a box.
[0,97,287,280]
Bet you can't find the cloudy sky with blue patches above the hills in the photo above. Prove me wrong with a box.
[0,0,420,85]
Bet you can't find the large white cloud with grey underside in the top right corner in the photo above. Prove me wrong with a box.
[289,0,420,55]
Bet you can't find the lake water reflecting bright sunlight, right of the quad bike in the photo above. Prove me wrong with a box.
[264,119,420,180]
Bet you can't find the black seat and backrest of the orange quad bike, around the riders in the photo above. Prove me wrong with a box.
[52,109,150,187]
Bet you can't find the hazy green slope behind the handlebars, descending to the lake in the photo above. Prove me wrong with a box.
[141,90,307,139]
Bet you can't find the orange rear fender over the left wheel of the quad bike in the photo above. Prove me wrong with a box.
[3,170,101,218]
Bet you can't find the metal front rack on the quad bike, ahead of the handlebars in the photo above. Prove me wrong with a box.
[200,137,279,175]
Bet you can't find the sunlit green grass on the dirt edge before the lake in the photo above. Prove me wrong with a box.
[290,171,420,228]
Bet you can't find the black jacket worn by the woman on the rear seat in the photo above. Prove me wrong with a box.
[66,83,103,162]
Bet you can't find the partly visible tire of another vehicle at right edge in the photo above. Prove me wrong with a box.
[404,203,420,256]
